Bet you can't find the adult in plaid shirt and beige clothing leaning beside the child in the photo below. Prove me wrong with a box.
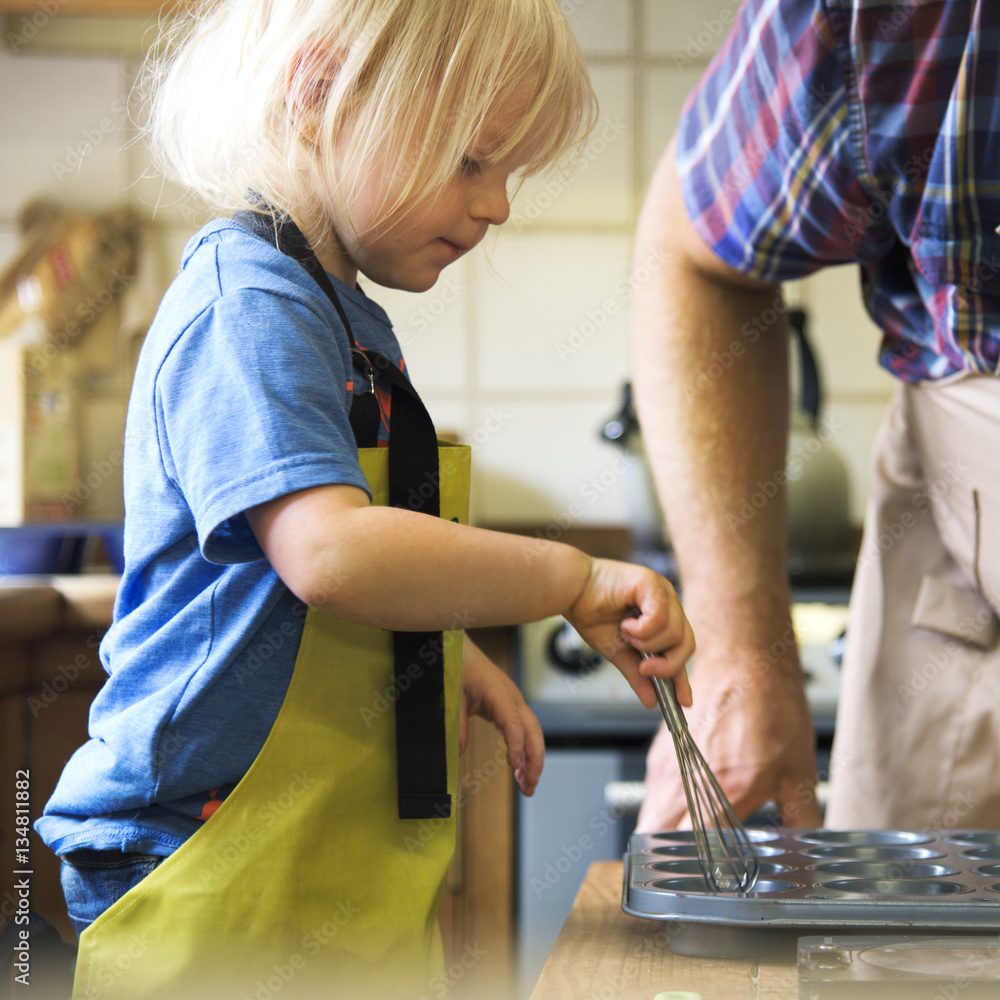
[632,0,1000,830]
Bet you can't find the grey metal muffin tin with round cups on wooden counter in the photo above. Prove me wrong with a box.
[622,829,1000,958]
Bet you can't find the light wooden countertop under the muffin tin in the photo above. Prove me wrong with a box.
[531,861,799,1000]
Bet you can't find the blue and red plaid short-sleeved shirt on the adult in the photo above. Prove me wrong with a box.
[677,0,1000,381]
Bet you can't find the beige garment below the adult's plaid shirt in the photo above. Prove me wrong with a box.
[826,375,1000,832]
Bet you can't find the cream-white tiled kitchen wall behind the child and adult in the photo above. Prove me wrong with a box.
[0,0,892,525]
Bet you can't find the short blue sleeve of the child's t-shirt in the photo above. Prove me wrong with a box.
[156,289,368,563]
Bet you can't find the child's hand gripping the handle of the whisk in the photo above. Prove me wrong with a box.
[566,559,694,708]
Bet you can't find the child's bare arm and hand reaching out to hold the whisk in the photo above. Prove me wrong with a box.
[247,486,694,708]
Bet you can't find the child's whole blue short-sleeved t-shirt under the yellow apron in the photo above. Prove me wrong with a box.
[36,220,401,855]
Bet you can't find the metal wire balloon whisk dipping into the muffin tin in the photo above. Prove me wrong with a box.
[652,677,760,893]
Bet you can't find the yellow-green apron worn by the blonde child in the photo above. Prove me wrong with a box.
[73,444,469,1000]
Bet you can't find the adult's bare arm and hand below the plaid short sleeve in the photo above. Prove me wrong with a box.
[631,139,820,830]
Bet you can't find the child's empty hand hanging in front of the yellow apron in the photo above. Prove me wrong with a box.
[458,636,545,795]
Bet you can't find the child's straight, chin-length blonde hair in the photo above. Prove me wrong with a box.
[140,0,596,235]
